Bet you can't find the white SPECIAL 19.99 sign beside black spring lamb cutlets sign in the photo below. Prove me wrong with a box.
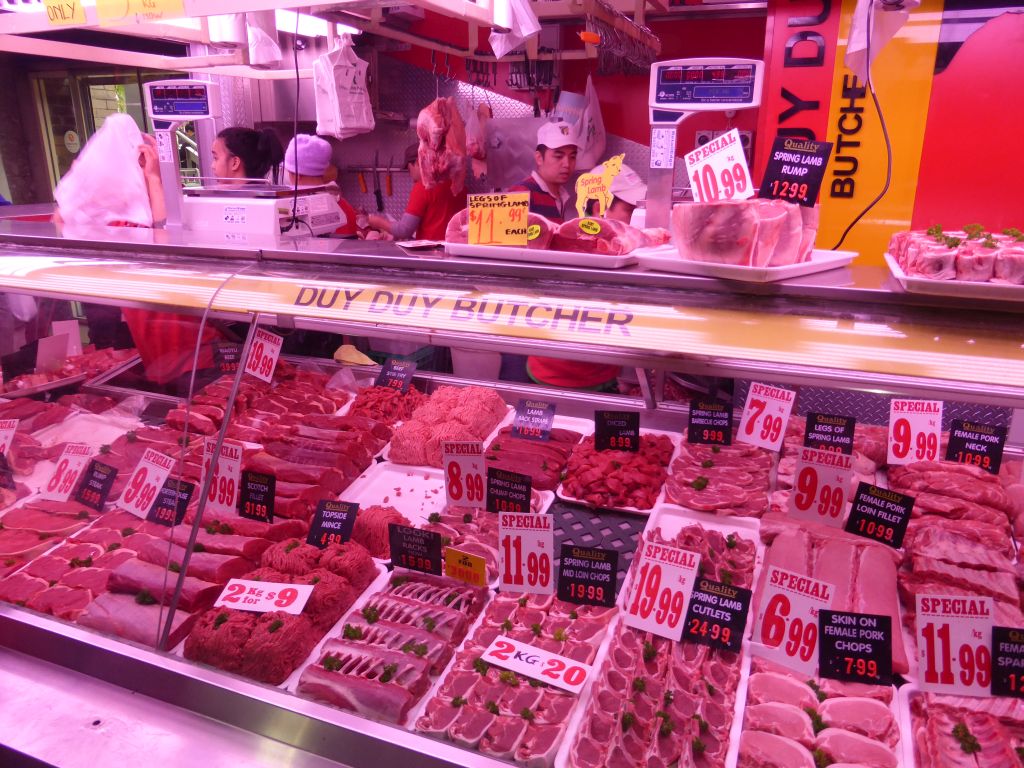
[625,542,700,640]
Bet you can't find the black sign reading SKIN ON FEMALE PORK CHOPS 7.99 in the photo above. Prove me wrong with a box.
[818,610,893,685]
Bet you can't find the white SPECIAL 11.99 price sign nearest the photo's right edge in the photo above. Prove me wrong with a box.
[916,595,995,696]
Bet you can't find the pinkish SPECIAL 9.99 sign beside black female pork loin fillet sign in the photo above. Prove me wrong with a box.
[788,447,853,528]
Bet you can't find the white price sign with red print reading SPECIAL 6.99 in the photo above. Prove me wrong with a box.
[752,565,835,676]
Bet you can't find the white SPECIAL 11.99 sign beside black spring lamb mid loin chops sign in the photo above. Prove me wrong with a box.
[498,512,555,595]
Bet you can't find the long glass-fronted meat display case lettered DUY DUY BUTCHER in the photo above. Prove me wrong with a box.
[0,223,1024,768]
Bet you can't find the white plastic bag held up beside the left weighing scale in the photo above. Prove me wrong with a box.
[53,114,153,226]
